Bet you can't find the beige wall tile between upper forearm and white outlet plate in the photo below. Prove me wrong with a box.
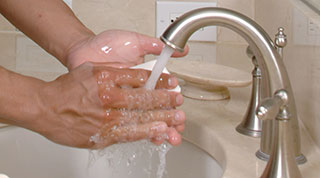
[73,0,155,36]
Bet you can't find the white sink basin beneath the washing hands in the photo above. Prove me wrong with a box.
[0,127,223,178]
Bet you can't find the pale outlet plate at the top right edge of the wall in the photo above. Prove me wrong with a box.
[293,9,320,46]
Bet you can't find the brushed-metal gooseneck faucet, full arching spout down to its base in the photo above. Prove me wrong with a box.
[161,7,306,178]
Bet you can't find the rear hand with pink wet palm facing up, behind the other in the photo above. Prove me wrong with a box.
[67,30,188,70]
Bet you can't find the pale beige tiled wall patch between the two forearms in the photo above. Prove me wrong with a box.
[0,32,66,81]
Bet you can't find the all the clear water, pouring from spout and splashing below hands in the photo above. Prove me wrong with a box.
[88,46,174,178]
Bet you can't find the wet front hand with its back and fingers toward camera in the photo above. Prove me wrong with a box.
[29,62,185,149]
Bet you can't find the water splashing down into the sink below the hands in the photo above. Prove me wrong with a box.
[88,140,172,178]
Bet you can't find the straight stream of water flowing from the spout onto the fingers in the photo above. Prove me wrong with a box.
[144,45,174,90]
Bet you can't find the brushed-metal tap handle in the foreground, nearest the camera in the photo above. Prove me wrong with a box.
[257,90,302,178]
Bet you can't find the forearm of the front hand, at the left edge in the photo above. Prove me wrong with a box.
[0,67,45,129]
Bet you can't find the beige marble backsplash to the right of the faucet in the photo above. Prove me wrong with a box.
[255,0,320,146]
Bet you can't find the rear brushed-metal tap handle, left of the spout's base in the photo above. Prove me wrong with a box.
[236,46,262,137]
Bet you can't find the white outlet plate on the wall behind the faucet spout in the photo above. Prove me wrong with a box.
[156,0,217,41]
